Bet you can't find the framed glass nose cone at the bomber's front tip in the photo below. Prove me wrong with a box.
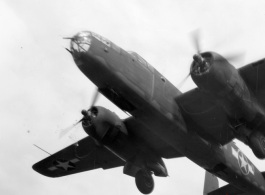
[70,31,92,54]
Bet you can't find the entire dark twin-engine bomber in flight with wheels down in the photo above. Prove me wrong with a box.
[33,31,265,195]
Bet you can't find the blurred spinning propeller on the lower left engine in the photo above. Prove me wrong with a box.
[59,88,99,139]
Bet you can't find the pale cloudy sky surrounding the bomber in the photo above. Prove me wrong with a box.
[0,0,265,195]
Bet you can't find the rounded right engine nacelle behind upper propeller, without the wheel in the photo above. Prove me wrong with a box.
[190,52,258,121]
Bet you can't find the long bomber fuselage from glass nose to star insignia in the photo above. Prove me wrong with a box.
[68,31,265,194]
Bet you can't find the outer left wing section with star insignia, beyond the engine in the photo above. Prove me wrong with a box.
[32,137,125,177]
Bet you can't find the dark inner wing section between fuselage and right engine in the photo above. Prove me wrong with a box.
[176,88,234,145]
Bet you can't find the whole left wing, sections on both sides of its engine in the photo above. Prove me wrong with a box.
[33,117,183,177]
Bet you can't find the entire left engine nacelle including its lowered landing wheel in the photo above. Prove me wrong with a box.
[82,107,168,193]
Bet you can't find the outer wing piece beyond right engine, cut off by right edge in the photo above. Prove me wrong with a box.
[238,59,265,107]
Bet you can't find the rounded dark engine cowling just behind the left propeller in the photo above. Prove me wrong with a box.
[82,106,128,144]
